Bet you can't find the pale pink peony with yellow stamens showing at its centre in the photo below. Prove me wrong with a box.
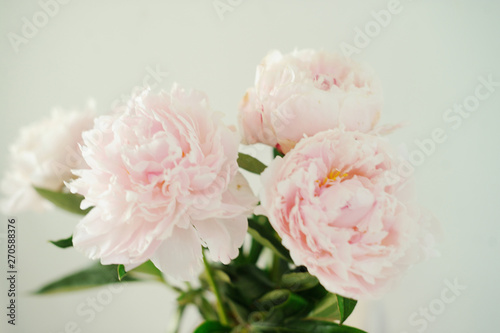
[261,129,433,299]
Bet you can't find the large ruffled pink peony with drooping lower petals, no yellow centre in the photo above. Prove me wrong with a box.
[70,87,257,280]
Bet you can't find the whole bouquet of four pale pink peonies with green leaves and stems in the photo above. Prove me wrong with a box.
[2,50,435,333]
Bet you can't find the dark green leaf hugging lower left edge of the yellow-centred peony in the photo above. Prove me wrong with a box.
[248,215,293,263]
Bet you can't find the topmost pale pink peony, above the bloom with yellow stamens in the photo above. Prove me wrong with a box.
[240,50,382,153]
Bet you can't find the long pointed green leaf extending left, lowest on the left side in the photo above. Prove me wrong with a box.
[35,263,137,294]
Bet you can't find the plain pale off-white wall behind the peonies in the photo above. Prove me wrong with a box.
[0,0,500,333]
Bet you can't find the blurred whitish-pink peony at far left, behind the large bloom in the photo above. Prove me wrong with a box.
[1,105,94,214]
